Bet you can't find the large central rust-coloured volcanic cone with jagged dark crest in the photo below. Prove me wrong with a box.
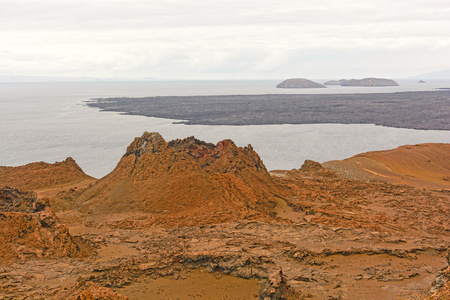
[80,132,279,226]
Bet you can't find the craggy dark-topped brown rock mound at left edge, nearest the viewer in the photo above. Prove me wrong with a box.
[0,187,89,262]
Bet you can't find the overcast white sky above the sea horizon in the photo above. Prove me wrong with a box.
[0,0,450,79]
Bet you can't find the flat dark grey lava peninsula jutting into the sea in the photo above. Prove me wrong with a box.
[84,90,450,130]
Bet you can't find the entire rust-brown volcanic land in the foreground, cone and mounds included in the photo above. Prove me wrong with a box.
[0,137,450,299]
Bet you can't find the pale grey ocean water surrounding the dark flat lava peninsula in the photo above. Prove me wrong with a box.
[0,80,450,178]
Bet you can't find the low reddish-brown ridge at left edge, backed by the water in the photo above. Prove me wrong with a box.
[0,157,94,191]
